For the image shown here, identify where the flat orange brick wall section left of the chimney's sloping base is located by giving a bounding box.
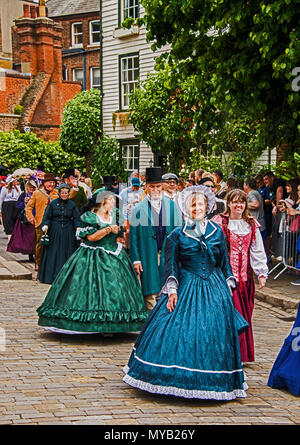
[0,74,30,114]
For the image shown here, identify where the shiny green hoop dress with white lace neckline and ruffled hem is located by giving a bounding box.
[37,212,148,333]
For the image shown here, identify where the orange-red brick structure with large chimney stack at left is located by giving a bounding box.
[0,2,81,140]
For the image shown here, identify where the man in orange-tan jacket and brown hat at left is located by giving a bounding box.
[25,173,58,270]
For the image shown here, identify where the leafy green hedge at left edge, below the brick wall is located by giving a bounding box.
[0,130,84,175]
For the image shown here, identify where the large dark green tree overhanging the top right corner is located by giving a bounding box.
[127,0,300,152]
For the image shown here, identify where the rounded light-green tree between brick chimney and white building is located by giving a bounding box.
[60,89,101,176]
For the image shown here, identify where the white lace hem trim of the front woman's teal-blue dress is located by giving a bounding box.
[123,366,248,400]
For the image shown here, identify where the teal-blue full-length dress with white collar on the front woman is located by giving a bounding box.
[123,221,248,400]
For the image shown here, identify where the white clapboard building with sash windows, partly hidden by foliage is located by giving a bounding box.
[100,0,169,171]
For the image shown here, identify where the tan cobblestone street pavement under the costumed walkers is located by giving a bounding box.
[0,280,300,425]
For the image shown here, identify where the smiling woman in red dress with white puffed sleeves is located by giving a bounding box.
[212,189,268,362]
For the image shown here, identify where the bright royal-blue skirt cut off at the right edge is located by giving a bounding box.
[268,305,300,396]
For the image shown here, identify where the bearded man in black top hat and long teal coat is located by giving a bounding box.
[129,167,182,312]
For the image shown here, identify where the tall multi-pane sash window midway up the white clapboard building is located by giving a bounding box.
[120,54,139,110]
